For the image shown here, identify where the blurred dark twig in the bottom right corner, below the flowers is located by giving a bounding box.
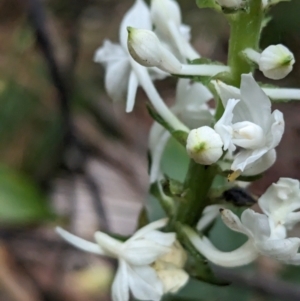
[214,267,300,301]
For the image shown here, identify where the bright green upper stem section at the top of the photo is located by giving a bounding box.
[228,0,264,87]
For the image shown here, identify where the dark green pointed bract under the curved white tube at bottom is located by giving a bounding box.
[175,222,229,286]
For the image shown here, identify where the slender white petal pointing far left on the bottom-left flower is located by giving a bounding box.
[56,227,109,255]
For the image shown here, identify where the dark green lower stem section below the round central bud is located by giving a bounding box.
[171,160,217,227]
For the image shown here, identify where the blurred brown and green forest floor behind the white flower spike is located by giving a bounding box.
[0,0,300,301]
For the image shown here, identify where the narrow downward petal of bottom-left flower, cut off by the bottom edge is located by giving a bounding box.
[111,259,129,301]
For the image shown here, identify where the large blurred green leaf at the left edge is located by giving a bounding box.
[0,166,54,226]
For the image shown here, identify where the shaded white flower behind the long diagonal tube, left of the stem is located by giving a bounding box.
[149,79,214,183]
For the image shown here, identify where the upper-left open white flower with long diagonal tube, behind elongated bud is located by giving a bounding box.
[94,0,188,131]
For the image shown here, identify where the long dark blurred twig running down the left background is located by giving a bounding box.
[29,0,107,228]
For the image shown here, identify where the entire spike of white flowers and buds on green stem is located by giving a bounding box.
[57,0,300,301]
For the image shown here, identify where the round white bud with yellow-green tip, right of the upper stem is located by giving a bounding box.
[258,44,295,79]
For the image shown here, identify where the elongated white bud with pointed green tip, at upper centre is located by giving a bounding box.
[127,27,181,73]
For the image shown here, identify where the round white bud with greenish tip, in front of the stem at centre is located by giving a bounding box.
[186,126,223,165]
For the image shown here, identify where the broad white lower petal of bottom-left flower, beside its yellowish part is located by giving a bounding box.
[127,265,163,301]
